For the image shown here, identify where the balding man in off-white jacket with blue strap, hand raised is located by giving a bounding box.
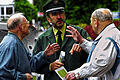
[66,8,120,80]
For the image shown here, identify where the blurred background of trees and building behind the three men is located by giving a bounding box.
[0,0,120,79]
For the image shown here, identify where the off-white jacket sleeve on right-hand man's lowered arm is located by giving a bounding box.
[73,40,117,78]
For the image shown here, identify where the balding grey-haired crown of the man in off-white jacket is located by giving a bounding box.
[92,8,113,21]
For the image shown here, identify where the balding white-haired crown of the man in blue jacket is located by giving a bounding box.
[7,13,25,30]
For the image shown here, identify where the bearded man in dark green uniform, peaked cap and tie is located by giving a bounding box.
[33,0,89,80]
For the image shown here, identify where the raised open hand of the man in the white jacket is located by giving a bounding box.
[66,26,84,43]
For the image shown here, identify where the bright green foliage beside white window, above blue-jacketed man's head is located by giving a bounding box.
[15,0,38,22]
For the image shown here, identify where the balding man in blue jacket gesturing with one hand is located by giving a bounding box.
[0,13,59,80]
